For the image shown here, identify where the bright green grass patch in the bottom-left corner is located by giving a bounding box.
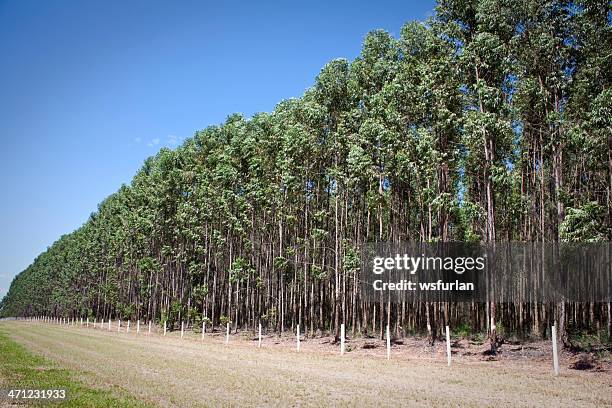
[0,329,150,407]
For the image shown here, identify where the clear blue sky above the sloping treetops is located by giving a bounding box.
[0,0,434,298]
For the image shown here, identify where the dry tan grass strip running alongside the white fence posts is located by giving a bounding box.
[0,321,612,407]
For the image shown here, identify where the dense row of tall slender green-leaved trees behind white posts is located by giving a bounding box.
[1,0,612,345]
